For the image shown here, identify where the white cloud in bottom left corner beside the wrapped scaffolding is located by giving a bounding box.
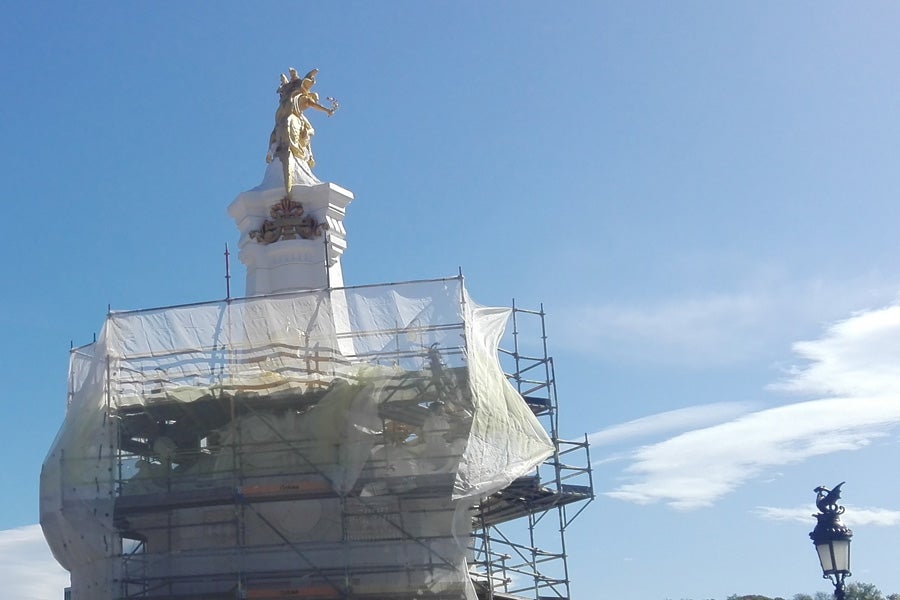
[0,525,69,600]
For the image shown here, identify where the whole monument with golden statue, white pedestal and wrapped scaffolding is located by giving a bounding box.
[41,69,593,600]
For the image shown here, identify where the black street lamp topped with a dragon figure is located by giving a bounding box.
[809,481,853,600]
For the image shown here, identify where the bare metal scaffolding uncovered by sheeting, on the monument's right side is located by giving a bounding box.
[472,301,594,600]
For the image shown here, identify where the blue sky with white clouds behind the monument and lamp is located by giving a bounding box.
[0,1,900,600]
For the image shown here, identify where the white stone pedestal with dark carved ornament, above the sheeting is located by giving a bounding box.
[228,182,353,296]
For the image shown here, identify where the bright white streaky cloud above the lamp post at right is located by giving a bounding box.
[594,306,900,508]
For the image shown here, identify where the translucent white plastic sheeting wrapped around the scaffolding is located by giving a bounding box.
[41,278,552,600]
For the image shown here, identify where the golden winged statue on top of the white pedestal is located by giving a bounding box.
[266,67,338,196]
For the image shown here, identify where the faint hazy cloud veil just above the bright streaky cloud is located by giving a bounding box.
[554,272,896,368]
